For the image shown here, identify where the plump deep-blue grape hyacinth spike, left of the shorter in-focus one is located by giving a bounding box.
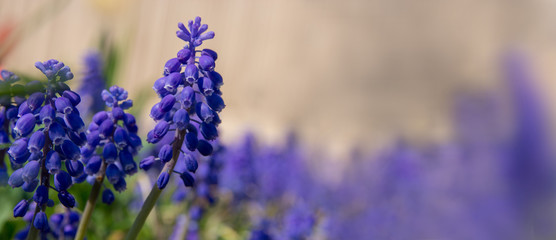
[8,59,86,237]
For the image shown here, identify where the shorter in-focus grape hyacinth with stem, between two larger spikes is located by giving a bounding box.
[76,86,142,239]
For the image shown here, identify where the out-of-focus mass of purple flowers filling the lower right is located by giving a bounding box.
[216,51,556,239]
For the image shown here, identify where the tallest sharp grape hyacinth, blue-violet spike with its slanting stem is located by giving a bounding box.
[126,17,225,239]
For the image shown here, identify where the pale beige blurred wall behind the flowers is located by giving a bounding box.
[0,0,556,157]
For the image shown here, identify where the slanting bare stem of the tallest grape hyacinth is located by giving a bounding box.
[125,130,185,240]
